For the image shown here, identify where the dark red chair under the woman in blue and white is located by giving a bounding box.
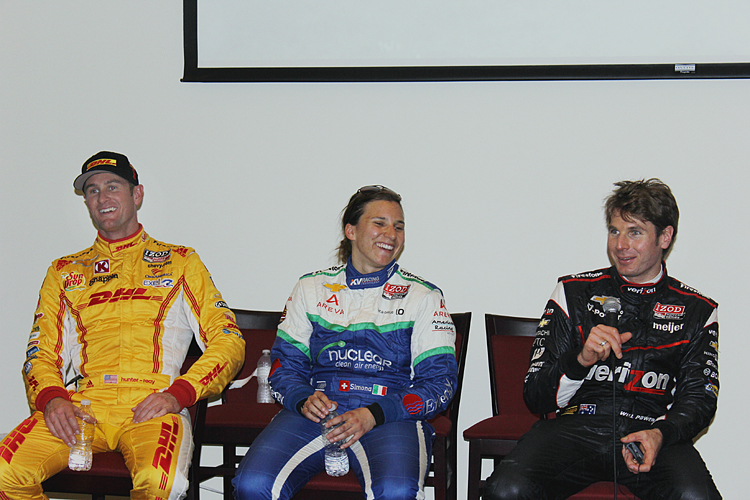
[295,312,471,500]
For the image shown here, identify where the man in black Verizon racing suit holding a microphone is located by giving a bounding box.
[485,179,721,500]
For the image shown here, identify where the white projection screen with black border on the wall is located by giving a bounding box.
[183,0,750,81]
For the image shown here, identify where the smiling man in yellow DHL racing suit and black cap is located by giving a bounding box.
[0,152,245,500]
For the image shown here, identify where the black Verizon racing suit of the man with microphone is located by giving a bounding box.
[488,265,720,498]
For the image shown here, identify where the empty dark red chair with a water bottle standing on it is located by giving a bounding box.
[196,309,282,500]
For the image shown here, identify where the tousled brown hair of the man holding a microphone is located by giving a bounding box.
[604,179,680,252]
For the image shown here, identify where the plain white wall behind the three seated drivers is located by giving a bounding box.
[0,0,750,498]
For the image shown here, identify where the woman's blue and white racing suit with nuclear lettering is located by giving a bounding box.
[234,260,457,499]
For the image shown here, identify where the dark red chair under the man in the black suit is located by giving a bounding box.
[463,314,635,500]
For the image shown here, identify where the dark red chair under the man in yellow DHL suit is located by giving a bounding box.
[42,340,207,500]
